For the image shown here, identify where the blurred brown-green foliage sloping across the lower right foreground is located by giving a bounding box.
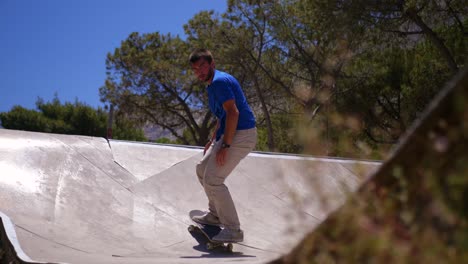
[273,68,468,264]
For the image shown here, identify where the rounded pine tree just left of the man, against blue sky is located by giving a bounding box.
[100,32,215,145]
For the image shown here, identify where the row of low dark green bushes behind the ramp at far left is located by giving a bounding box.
[0,96,146,141]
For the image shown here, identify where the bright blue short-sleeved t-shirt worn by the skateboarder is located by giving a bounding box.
[207,70,255,140]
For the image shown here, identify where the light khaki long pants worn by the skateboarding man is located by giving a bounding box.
[196,128,257,229]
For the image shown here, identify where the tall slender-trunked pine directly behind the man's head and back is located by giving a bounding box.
[185,4,288,151]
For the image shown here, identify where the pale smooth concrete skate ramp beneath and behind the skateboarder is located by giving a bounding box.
[0,129,380,263]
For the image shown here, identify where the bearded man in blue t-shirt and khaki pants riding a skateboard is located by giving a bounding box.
[189,49,257,242]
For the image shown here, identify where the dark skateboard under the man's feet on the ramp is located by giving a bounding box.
[188,210,234,252]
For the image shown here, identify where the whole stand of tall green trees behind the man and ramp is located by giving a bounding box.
[100,0,468,158]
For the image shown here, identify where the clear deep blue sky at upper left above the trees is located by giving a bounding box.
[0,0,227,112]
